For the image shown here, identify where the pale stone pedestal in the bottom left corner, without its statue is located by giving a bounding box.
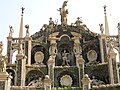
[0,72,12,90]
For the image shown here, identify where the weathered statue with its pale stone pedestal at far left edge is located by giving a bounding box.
[0,42,12,90]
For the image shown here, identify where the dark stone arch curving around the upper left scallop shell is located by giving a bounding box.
[31,45,49,65]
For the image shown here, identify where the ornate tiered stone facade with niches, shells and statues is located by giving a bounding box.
[0,1,120,90]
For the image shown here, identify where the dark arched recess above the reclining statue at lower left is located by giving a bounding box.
[25,70,45,86]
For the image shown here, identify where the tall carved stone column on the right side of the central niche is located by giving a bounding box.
[72,32,85,87]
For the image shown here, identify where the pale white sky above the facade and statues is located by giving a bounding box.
[0,0,120,54]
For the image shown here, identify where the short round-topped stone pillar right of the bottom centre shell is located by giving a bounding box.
[82,74,91,90]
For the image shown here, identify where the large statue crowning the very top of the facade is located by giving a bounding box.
[58,1,68,25]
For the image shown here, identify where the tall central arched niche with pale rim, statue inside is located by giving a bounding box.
[55,34,76,66]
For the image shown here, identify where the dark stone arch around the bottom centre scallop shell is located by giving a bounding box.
[56,70,78,87]
